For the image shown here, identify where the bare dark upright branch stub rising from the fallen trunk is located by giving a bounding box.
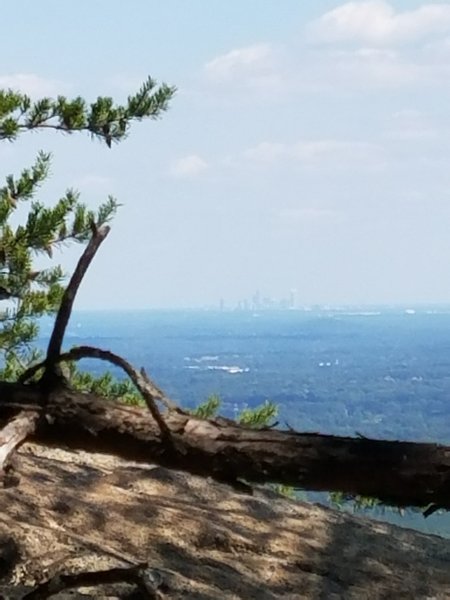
[42,224,109,380]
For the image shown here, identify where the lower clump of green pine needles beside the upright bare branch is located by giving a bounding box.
[0,153,117,368]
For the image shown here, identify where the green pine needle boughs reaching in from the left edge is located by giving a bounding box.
[0,78,175,381]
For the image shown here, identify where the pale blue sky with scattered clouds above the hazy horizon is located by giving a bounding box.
[0,0,450,308]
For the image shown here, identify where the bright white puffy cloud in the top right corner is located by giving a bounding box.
[309,0,450,45]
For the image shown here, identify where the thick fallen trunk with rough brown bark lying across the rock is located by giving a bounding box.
[0,382,450,508]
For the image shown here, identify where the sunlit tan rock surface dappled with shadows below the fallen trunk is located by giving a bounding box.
[0,444,450,600]
